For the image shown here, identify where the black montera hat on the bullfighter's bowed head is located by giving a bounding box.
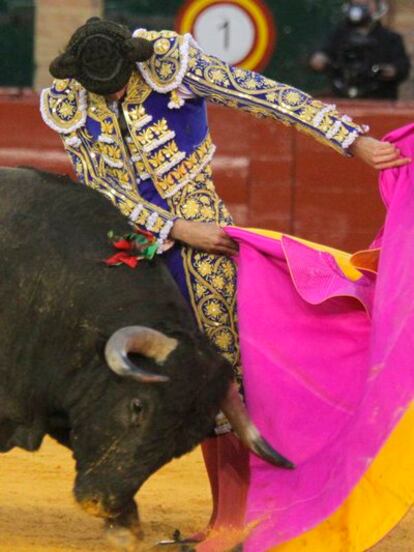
[49,17,154,95]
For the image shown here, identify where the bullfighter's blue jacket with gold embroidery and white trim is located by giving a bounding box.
[41,29,365,241]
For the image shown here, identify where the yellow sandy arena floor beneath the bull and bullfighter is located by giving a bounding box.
[0,440,414,552]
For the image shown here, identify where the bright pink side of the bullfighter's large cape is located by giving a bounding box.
[227,125,414,552]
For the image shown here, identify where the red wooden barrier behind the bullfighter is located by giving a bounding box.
[0,92,414,250]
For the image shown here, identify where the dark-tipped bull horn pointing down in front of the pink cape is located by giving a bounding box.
[221,384,295,470]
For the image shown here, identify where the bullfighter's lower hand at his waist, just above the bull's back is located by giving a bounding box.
[170,219,238,257]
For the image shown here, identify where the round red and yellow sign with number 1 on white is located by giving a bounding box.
[176,0,276,71]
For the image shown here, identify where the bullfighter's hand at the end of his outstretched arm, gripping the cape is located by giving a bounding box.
[350,136,412,170]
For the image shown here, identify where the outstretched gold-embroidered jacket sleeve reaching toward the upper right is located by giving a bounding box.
[182,45,368,154]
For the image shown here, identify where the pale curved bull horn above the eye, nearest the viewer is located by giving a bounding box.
[105,326,178,383]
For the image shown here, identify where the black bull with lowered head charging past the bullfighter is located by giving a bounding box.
[0,169,288,544]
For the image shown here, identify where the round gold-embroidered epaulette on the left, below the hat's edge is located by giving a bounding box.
[40,79,88,134]
